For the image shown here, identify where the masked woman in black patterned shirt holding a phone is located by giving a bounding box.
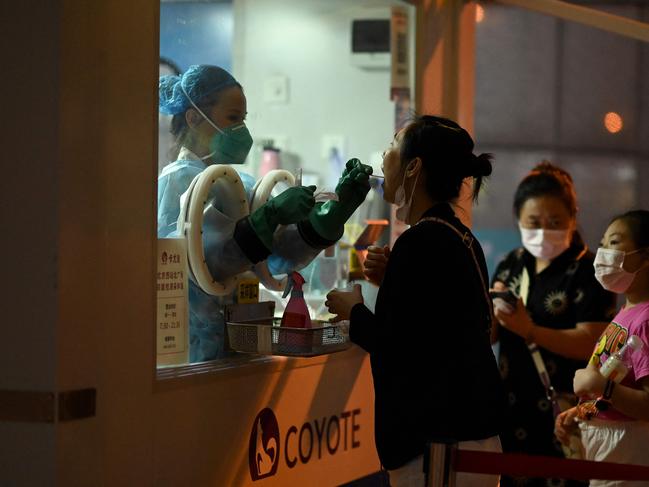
[493,162,615,487]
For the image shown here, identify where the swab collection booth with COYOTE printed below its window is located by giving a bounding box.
[0,0,647,487]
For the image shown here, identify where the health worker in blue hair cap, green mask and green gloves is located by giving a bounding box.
[158,65,372,362]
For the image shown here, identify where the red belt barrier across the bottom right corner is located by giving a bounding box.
[453,450,649,480]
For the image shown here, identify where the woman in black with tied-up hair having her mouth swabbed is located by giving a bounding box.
[325,116,505,487]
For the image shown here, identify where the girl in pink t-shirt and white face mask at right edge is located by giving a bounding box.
[556,210,649,487]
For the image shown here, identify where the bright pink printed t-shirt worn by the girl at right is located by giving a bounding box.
[589,302,649,421]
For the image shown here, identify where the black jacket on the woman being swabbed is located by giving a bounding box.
[350,204,506,470]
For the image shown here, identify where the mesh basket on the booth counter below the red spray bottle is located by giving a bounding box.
[227,318,351,357]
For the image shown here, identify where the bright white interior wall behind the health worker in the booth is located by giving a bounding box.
[232,0,408,188]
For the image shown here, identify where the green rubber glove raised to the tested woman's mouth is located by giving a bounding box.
[309,159,372,241]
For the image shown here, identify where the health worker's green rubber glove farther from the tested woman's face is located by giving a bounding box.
[248,186,316,250]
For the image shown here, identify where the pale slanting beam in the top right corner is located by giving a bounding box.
[496,0,649,42]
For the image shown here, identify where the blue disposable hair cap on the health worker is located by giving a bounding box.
[158,64,240,115]
